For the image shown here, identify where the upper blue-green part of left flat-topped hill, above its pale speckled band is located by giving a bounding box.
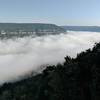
[0,23,65,32]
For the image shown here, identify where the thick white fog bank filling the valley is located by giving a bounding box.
[0,31,100,83]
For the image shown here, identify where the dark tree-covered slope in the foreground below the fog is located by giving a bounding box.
[0,43,100,100]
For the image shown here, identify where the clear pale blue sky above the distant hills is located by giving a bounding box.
[0,0,100,26]
